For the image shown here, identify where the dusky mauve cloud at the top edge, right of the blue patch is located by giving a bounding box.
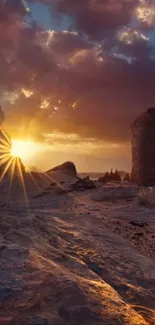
[51,0,139,38]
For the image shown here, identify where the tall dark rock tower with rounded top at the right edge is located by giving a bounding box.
[131,108,155,186]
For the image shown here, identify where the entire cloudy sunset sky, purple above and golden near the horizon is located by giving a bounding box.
[0,0,155,172]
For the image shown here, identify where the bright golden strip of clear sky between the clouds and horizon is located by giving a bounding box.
[12,133,130,172]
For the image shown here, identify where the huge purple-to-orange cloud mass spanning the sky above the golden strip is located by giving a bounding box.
[0,0,155,143]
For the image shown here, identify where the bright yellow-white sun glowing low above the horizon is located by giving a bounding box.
[11,140,37,159]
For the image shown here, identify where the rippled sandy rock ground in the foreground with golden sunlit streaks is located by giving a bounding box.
[0,176,155,325]
